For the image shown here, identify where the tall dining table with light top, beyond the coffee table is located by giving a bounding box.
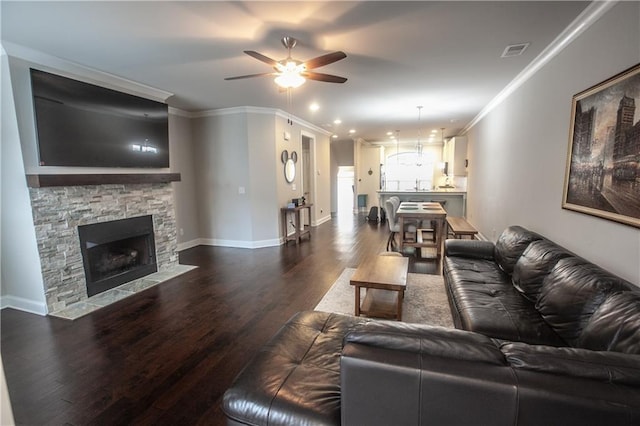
[396,202,447,258]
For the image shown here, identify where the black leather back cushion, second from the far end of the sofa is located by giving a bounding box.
[512,239,571,303]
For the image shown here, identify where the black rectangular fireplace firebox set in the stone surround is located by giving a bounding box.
[78,215,158,297]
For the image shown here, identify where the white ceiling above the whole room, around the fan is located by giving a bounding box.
[0,0,588,142]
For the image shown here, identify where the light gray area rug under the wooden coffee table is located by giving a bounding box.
[315,268,453,327]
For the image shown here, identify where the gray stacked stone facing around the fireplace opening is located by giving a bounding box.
[30,183,178,312]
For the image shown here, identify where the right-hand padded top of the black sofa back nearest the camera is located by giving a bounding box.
[500,342,640,386]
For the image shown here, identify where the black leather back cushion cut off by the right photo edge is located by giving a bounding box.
[578,291,640,354]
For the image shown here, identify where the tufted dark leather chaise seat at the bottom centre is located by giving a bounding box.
[222,311,370,425]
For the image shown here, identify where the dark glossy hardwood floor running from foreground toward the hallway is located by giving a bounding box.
[1,215,440,425]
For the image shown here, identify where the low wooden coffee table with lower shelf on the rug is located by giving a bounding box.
[350,256,409,321]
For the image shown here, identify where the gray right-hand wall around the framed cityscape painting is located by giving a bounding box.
[467,2,640,284]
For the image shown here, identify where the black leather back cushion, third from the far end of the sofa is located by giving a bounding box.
[536,257,633,346]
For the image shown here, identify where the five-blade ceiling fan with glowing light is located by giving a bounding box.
[225,37,347,89]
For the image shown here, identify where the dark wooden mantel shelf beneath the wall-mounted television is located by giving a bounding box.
[27,173,181,188]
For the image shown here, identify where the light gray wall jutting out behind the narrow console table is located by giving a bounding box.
[192,107,329,248]
